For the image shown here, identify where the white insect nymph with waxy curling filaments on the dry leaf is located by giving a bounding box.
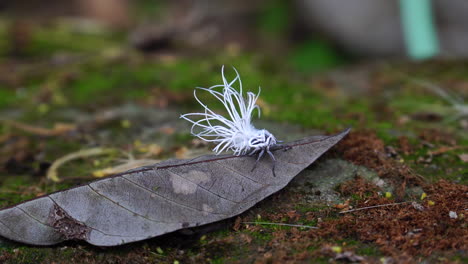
[181,66,277,161]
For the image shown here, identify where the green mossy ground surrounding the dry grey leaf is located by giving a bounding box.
[0,17,468,263]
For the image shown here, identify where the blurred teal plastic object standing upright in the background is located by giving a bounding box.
[400,0,439,60]
